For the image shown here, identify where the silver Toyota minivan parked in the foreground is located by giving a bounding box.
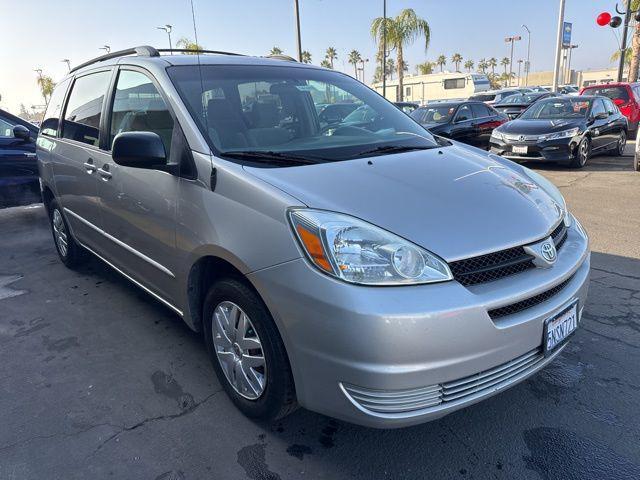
[37,47,590,428]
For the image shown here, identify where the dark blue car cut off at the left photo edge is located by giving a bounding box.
[0,110,39,207]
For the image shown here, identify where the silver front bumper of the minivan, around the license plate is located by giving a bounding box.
[250,224,590,428]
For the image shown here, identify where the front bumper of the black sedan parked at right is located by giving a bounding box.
[490,136,581,162]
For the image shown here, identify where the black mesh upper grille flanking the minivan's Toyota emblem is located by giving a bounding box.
[449,222,567,286]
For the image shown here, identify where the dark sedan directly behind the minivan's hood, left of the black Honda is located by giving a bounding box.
[411,101,508,149]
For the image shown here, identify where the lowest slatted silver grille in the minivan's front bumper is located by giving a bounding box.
[342,347,544,415]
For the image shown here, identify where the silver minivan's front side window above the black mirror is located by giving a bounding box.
[109,70,173,152]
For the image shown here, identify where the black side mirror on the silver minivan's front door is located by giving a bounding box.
[111,132,167,170]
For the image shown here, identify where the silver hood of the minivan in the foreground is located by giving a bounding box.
[245,144,562,261]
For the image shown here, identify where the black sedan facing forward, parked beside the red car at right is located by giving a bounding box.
[491,96,628,168]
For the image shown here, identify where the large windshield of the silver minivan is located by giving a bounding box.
[167,65,438,161]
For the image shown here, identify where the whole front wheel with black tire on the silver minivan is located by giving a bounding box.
[203,278,297,421]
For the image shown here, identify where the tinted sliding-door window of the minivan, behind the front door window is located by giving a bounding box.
[62,71,111,147]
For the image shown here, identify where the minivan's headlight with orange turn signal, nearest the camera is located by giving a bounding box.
[289,209,453,285]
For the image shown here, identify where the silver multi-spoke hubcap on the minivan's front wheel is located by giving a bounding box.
[211,301,267,400]
